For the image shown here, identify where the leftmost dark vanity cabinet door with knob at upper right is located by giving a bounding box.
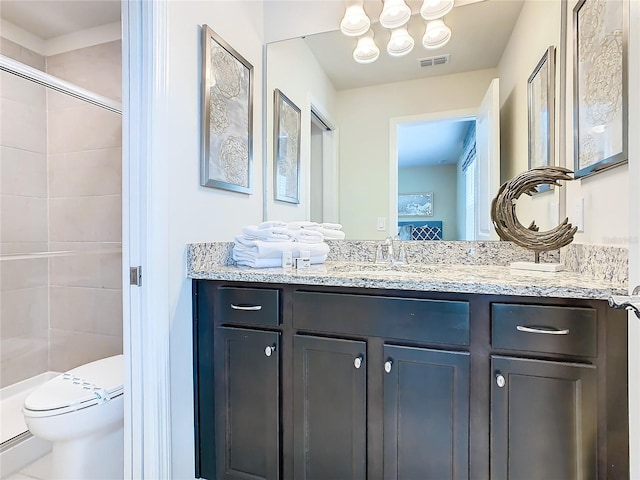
[214,327,280,480]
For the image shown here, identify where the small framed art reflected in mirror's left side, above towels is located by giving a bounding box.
[273,88,300,203]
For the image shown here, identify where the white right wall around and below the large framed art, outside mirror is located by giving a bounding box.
[565,0,636,247]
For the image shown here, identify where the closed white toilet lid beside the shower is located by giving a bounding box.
[24,355,124,411]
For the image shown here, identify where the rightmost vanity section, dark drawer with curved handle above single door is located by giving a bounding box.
[490,303,598,480]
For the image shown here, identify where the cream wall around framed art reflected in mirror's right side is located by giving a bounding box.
[498,0,564,230]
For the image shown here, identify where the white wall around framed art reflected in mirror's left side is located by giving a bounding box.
[265,38,336,221]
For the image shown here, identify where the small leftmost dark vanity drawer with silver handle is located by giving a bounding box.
[218,287,280,326]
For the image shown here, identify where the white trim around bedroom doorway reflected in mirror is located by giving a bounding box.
[387,108,478,235]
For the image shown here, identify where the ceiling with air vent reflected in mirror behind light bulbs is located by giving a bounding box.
[304,0,524,90]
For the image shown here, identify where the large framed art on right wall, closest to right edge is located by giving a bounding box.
[573,0,628,178]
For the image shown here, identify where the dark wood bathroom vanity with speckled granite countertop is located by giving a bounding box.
[189,256,628,480]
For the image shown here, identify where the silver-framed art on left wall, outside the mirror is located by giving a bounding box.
[200,25,253,193]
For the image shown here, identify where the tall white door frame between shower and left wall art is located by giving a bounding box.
[121,0,172,479]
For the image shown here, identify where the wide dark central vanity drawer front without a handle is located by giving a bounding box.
[293,291,469,345]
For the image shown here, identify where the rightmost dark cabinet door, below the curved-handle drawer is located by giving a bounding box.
[491,356,598,480]
